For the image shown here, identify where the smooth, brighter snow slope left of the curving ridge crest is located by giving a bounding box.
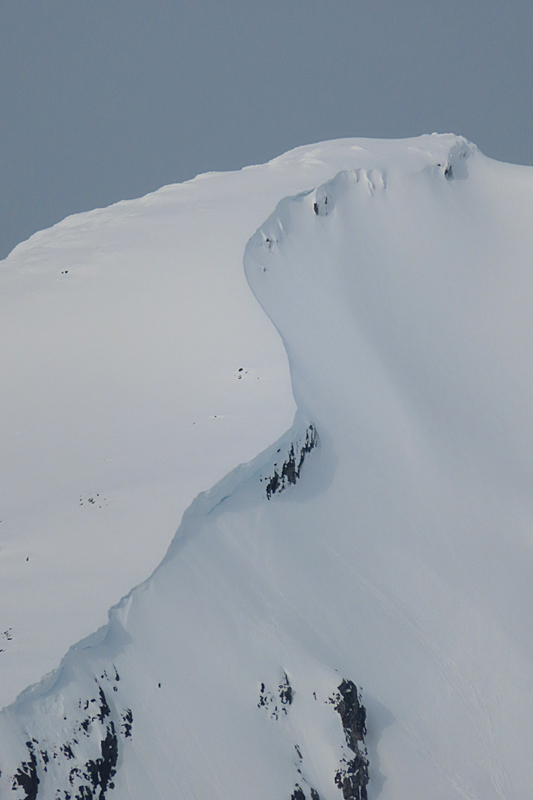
[0,142,376,707]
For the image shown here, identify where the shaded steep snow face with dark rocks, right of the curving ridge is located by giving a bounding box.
[0,136,533,800]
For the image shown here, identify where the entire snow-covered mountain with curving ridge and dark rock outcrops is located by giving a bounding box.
[0,135,533,800]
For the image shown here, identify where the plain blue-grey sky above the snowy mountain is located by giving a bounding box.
[0,0,533,257]
